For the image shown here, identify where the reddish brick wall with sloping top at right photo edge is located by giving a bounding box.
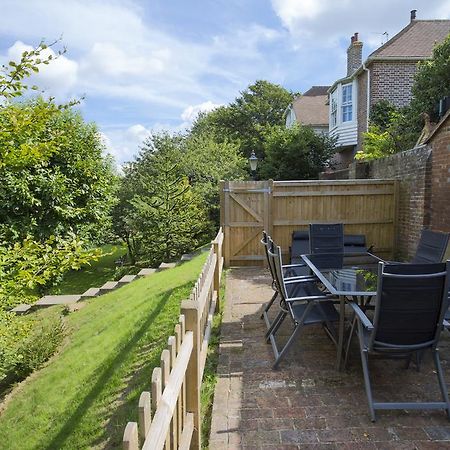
[429,116,450,237]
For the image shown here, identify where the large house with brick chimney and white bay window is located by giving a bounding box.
[328,10,450,168]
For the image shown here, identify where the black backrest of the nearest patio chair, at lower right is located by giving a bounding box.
[370,262,450,351]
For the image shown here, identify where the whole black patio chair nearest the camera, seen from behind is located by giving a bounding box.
[350,261,450,422]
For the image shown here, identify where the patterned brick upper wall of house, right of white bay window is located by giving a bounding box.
[370,61,417,107]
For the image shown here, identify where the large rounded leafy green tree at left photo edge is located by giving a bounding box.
[0,98,115,241]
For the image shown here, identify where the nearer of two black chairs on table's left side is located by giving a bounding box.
[266,242,339,369]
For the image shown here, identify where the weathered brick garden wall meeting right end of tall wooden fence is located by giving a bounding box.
[349,146,431,260]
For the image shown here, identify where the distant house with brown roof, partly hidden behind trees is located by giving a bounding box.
[285,86,330,134]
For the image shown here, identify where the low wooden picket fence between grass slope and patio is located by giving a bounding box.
[123,229,224,450]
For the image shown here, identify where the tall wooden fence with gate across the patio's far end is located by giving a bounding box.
[220,180,398,266]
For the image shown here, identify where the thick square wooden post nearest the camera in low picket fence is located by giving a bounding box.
[181,300,201,450]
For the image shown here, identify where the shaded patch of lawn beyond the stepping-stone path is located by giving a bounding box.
[49,245,127,294]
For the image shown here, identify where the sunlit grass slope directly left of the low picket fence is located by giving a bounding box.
[0,254,206,450]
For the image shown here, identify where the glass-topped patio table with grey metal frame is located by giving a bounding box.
[302,253,383,370]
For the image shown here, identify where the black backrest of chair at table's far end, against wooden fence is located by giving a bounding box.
[309,223,344,253]
